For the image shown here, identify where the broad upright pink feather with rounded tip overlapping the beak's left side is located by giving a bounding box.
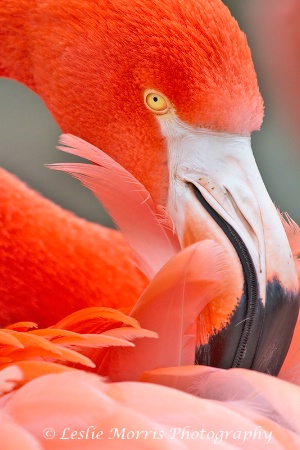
[93,241,237,381]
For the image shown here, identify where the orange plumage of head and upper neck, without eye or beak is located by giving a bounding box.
[0,0,263,204]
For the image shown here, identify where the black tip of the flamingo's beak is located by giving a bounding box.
[195,278,299,376]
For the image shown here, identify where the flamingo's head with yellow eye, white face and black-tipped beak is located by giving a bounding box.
[6,0,299,373]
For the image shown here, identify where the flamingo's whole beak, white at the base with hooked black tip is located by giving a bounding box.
[160,118,299,375]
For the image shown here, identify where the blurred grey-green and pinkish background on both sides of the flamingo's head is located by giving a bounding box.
[0,0,300,226]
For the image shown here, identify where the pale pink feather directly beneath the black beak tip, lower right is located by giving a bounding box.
[141,366,300,449]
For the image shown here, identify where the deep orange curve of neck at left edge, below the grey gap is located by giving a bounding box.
[0,170,148,326]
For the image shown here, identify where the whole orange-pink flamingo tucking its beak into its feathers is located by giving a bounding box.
[0,0,299,449]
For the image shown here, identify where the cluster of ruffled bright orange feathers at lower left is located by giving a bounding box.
[0,307,157,384]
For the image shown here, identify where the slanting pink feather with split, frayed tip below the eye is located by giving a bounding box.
[48,134,179,279]
